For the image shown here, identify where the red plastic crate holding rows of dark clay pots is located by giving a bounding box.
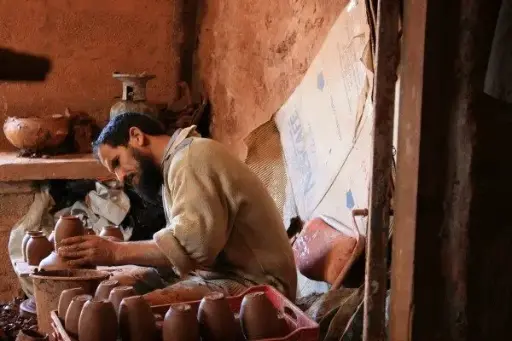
[152,285,319,341]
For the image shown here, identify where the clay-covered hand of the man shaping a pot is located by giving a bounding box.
[57,236,119,265]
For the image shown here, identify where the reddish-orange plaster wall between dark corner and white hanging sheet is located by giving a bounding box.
[198,0,348,158]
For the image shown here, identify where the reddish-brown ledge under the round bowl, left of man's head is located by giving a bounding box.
[0,152,112,182]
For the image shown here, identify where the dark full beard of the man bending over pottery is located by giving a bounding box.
[127,148,163,204]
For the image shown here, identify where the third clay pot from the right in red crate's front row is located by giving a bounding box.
[163,304,199,341]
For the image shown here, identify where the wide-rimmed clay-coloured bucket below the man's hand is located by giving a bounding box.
[30,269,110,333]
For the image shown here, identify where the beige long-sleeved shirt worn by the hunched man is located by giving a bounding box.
[154,127,297,299]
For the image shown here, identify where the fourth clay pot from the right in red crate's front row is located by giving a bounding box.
[119,296,157,341]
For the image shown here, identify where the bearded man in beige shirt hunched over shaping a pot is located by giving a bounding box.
[58,113,297,304]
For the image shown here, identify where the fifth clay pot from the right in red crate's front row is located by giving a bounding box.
[78,299,117,341]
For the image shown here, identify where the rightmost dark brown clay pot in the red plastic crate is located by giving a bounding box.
[240,292,286,340]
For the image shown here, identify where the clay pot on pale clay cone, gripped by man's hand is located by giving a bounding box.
[39,215,85,270]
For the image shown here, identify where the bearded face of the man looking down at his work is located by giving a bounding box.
[98,145,163,203]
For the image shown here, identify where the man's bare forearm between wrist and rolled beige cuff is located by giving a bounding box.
[115,240,172,267]
